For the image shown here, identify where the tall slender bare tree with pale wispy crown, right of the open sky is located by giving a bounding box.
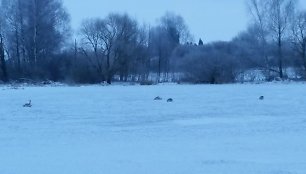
[248,0,296,78]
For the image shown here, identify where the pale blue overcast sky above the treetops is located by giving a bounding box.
[63,0,306,42]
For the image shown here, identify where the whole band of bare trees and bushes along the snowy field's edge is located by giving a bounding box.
[0,0,306,84]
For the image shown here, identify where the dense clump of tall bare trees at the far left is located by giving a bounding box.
[2,0,70,78]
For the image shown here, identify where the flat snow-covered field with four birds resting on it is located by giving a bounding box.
[0,84,306,174]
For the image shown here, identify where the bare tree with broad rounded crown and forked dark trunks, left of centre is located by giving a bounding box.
[81,14,139,84]
